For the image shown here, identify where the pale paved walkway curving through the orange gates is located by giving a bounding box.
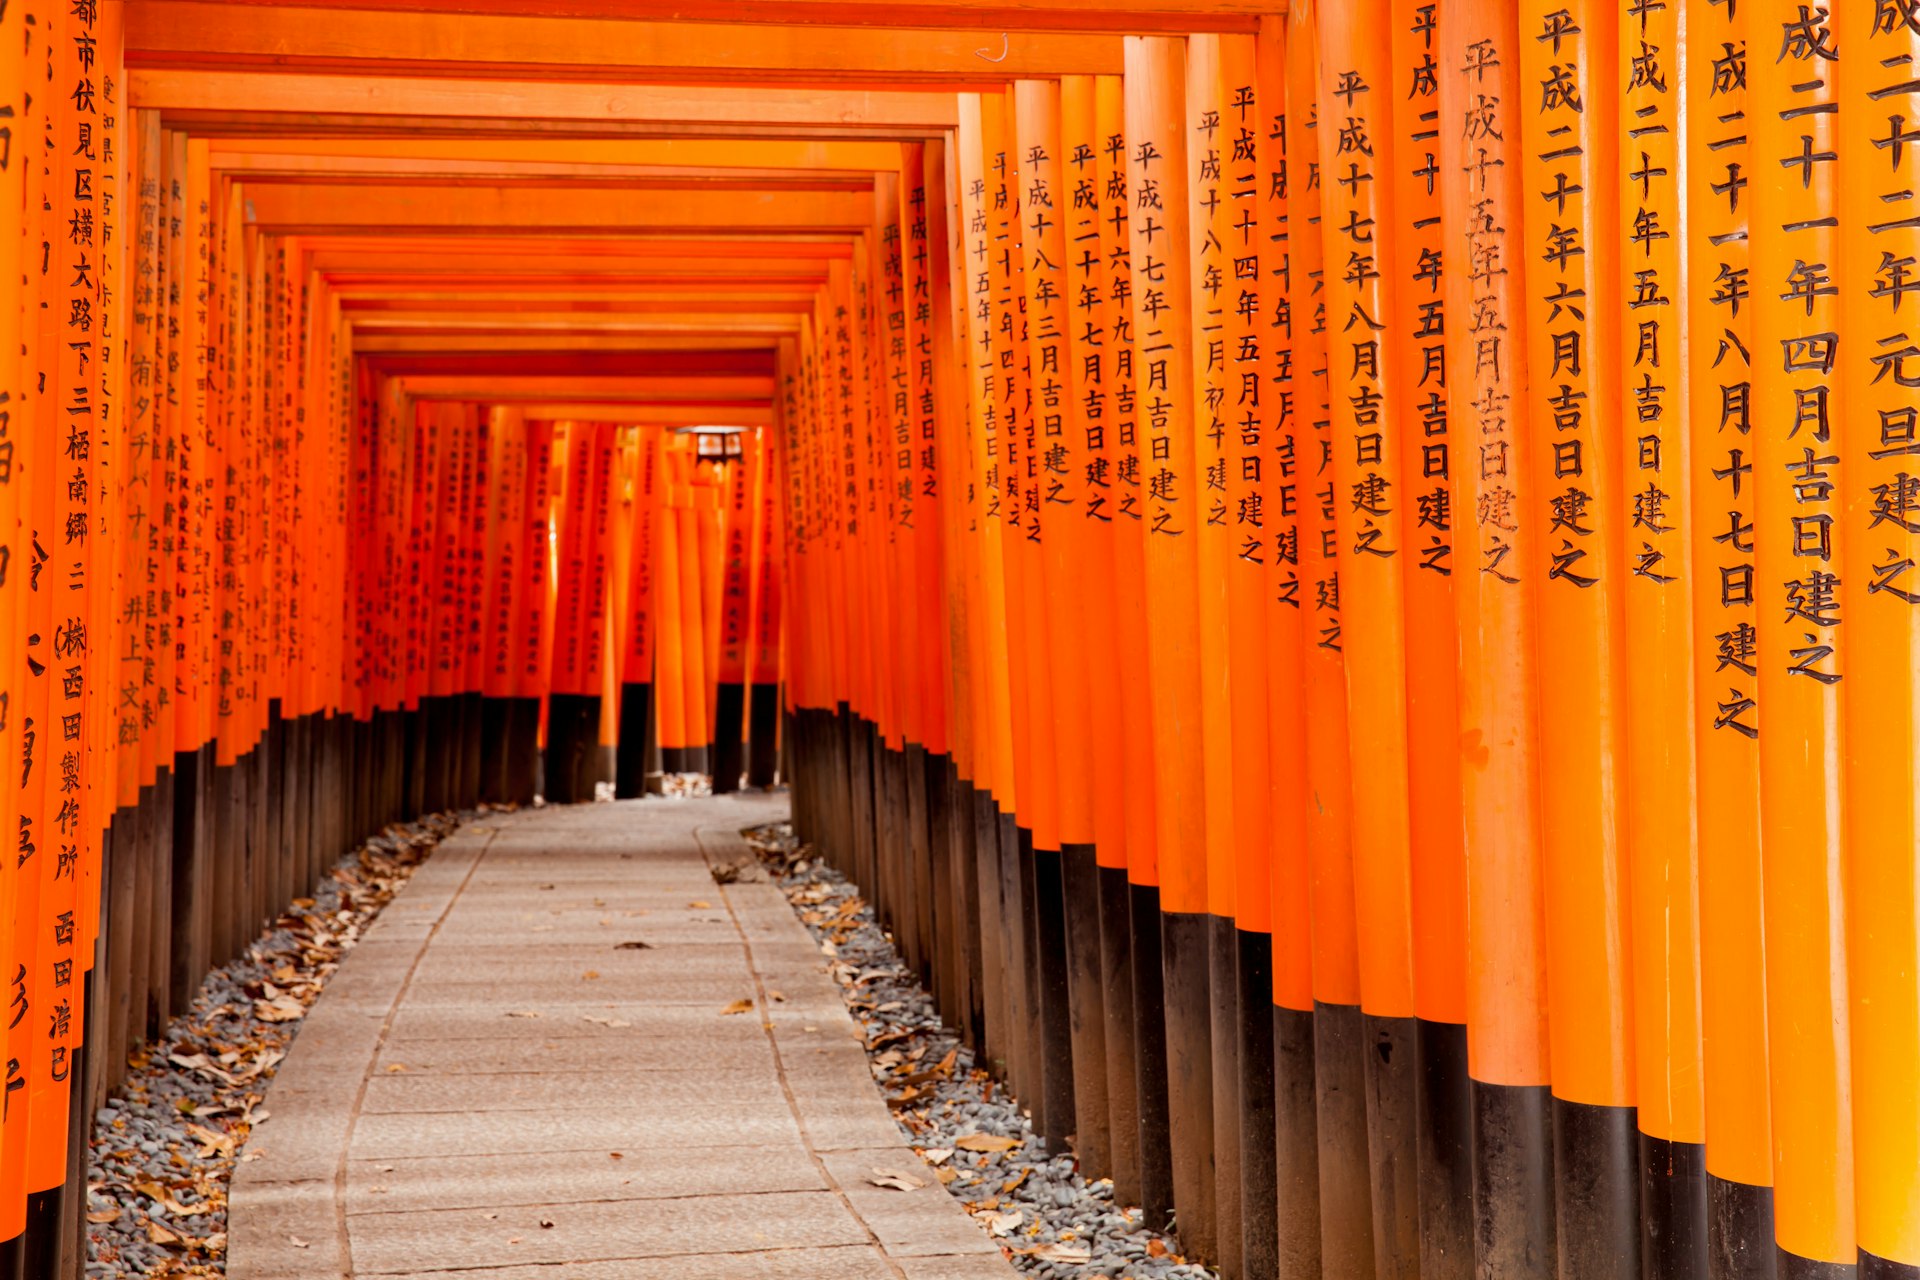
[227,796,1014,1280]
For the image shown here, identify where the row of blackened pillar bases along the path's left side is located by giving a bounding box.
[0,695,568,1280]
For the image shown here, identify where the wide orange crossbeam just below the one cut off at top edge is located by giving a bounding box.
[127,0,1123,84]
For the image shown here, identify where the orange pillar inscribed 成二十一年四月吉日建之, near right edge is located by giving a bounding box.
[1758,0,1858,1276]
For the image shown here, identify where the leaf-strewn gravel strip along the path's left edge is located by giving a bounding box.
[86,814,478,1280]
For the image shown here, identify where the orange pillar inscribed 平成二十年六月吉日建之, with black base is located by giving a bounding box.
[1521,0,1635,1274]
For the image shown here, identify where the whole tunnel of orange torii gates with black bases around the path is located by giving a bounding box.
[0,0,1920,1280]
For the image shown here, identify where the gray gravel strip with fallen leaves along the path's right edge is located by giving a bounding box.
[745,823,1213,1280]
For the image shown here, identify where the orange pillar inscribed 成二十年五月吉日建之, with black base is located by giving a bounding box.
[1599,0,1711,1280]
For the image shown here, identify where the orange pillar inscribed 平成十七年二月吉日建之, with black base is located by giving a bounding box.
[1125,36,1219,1257]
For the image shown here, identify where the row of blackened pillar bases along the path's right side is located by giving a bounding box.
[783,706,1781,1280]
